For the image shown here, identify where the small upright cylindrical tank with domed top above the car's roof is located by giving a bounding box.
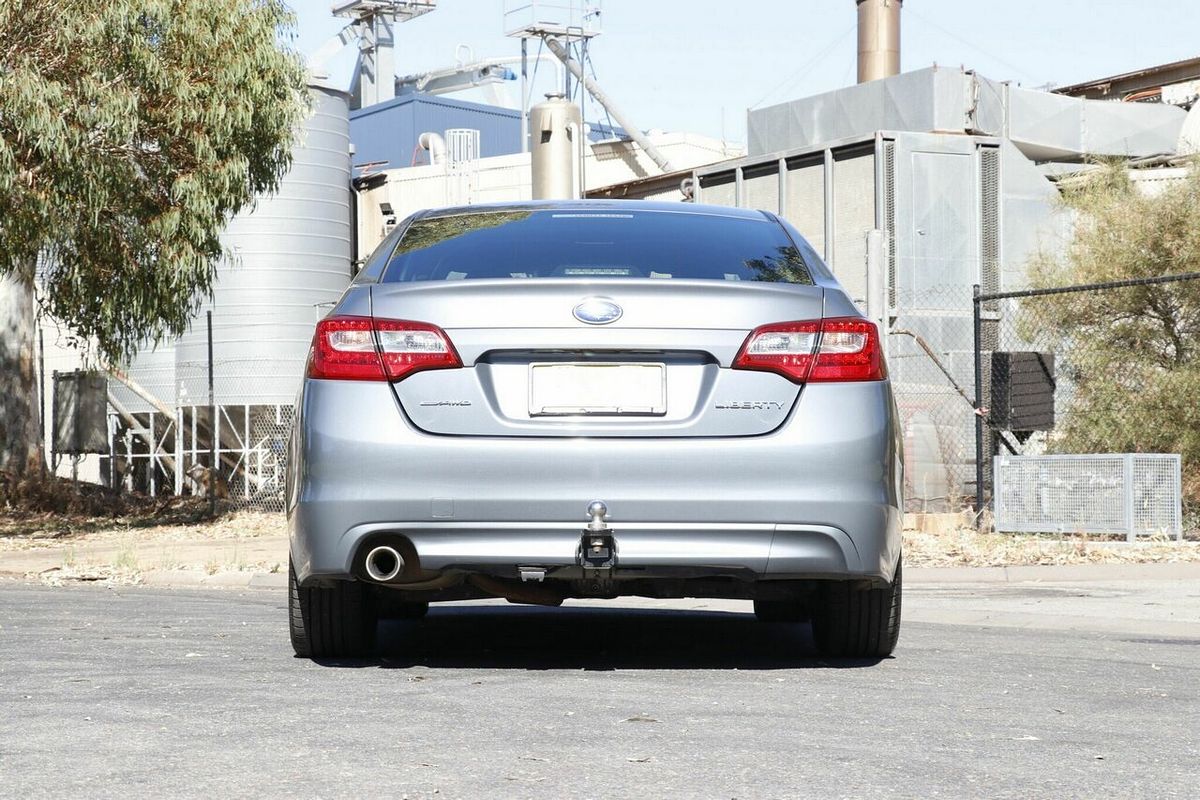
[529,95,583,200]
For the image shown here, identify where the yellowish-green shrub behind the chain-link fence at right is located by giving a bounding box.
[1022,166,1200,500]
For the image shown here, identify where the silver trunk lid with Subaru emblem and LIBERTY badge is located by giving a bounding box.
[371,278,823,437]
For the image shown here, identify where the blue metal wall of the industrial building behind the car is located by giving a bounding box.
[350,94,521,169]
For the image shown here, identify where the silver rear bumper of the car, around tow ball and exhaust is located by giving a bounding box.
[288,380,901,582]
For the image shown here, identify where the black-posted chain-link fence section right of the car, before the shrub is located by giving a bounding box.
[971,273,1200,529]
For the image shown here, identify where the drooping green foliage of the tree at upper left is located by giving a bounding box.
[0,0,307,361]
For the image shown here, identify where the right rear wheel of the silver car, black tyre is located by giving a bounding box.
[812,556,902,658]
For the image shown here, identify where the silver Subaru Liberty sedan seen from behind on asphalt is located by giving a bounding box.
[288,201,902,657]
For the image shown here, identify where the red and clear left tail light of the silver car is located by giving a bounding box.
[308,317,462,380]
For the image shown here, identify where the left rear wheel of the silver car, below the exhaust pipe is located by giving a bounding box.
[288,559,379,658]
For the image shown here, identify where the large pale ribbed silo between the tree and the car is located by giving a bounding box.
[175,84,352,405]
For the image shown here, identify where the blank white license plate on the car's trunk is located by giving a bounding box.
[529,363,667,416]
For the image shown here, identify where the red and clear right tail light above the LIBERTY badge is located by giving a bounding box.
[733,317,887,384]
